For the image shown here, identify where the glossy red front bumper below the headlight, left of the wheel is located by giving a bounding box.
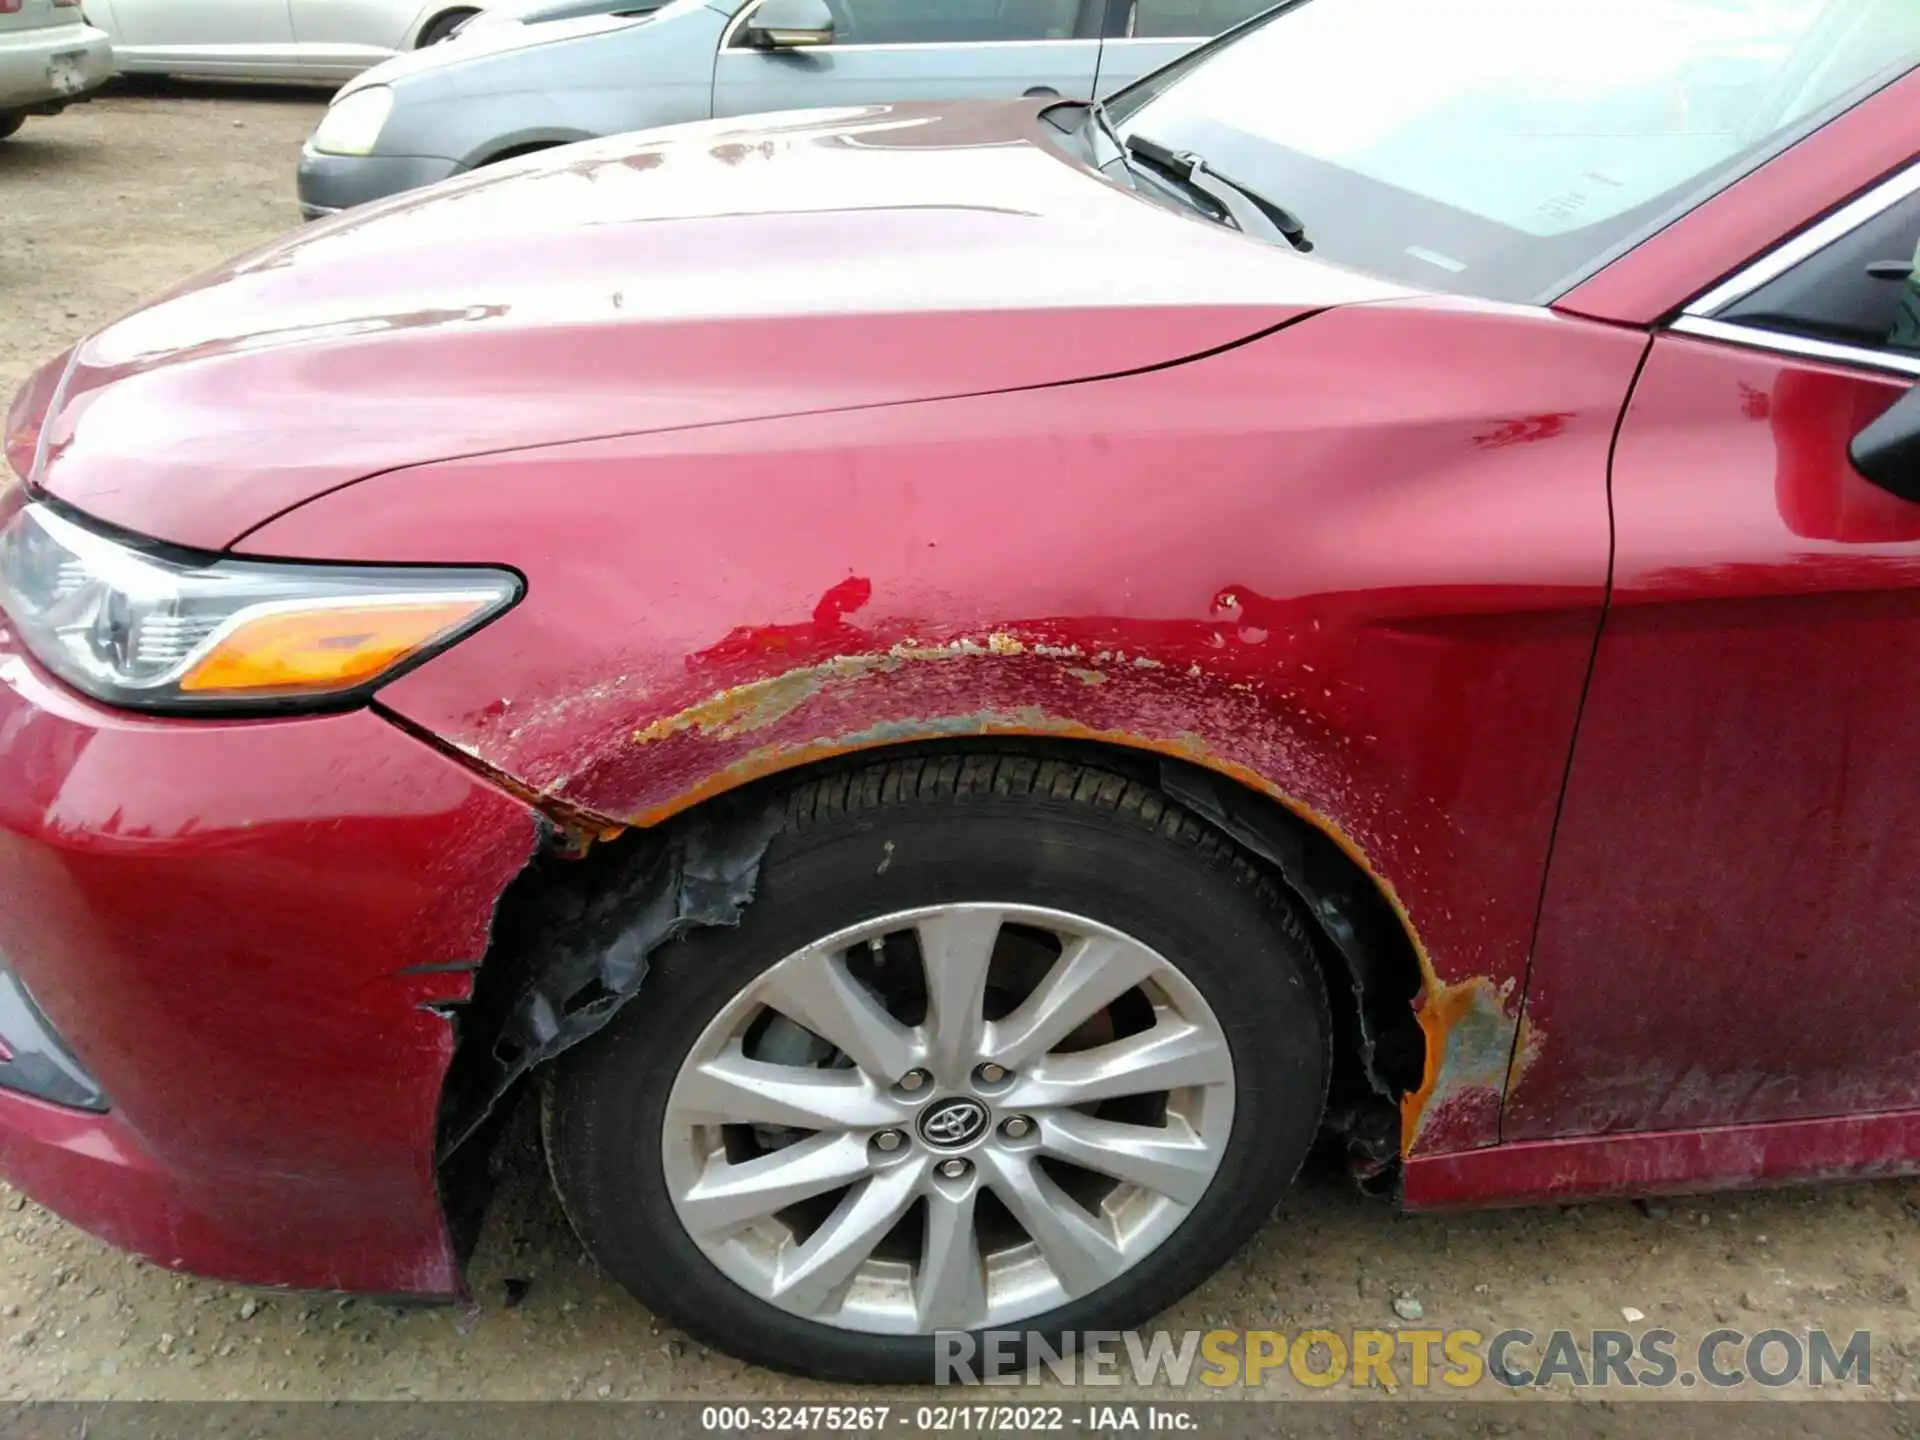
[0,622,538,1296]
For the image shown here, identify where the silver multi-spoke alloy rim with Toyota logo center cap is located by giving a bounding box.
[660,895,1236,1336]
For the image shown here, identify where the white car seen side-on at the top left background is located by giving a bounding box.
[86,0,579,81]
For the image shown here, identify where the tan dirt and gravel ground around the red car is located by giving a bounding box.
[0,88,1920,1400]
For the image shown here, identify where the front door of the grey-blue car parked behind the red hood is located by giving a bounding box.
[714,0,1102,115]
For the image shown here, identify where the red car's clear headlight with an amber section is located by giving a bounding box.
[0,503,520,710]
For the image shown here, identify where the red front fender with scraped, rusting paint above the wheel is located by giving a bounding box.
[248,303,1640,1148]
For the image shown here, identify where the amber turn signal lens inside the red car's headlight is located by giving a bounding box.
[180,595,499,695]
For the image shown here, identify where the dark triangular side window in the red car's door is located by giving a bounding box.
[1715,194,1920,357]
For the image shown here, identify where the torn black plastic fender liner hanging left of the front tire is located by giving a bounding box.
[440,797,785,1160]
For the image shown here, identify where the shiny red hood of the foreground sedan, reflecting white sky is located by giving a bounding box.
[36,102,1396,549]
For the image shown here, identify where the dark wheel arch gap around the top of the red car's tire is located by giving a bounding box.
[440,733,1428,1252]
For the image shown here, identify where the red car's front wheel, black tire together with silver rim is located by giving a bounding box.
[543,756,1331,1382]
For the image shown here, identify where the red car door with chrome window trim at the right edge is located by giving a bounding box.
[1501,167,1920,1139]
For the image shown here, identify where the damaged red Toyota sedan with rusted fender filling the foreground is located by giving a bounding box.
[0,0,1920,1379]
